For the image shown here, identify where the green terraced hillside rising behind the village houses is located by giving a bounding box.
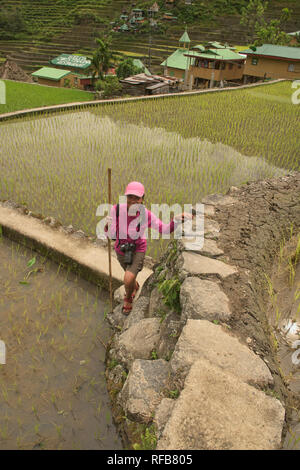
[0,0,300,71]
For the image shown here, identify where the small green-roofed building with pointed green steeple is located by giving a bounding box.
[160,30,193,81]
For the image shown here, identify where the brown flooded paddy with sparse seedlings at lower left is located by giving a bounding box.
[0,237,122,450]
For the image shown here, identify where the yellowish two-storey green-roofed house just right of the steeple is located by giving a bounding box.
[185,42,245,88]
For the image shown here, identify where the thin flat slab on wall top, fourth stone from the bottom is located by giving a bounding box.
[176,252,238,279]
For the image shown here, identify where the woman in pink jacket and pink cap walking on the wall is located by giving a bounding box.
[108,181,191,315]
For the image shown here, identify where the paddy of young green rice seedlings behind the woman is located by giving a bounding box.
[0,83,299,260]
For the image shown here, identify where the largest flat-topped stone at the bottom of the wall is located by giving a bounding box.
[157,359,285,450]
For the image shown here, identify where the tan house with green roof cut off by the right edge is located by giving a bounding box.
[243,44,300,83]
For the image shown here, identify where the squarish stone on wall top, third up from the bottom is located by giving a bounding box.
[180,277,231,321]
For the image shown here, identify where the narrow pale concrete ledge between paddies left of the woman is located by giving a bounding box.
[0,203,152,289]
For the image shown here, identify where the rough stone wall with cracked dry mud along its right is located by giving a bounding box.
[107,173,300,450]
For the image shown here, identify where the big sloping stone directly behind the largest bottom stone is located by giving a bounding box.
[170,320,273,387]
